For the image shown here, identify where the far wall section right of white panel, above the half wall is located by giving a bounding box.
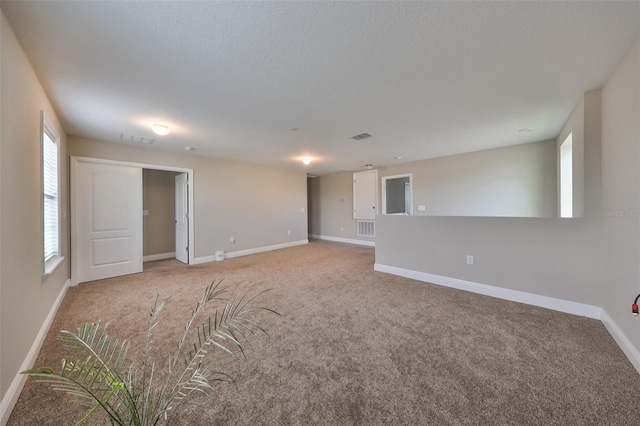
[380,140,557,217]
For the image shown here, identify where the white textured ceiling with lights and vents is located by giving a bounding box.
[1,1,640,174]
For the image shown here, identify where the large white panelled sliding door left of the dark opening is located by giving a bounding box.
[72,160,142,283]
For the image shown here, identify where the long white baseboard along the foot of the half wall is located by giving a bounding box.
[373,263,602,319]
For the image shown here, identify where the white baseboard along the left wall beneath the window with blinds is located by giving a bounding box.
[0,280,71,425]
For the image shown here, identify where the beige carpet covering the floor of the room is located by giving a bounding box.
[9,241,640,426]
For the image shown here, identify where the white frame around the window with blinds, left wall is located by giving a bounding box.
[40,111,64,280]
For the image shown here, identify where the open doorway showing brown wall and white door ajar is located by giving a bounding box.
[142,169,189,264]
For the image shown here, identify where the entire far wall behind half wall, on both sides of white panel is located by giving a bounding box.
[309,140,557,242]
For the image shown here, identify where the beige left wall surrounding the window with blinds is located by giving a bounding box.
[0,10,69,408]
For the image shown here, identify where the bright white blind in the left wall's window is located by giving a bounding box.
[42,120,60,263]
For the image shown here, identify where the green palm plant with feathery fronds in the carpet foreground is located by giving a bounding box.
[22,280,278,426]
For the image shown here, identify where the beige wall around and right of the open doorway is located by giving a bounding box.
[69,136,307,261]
